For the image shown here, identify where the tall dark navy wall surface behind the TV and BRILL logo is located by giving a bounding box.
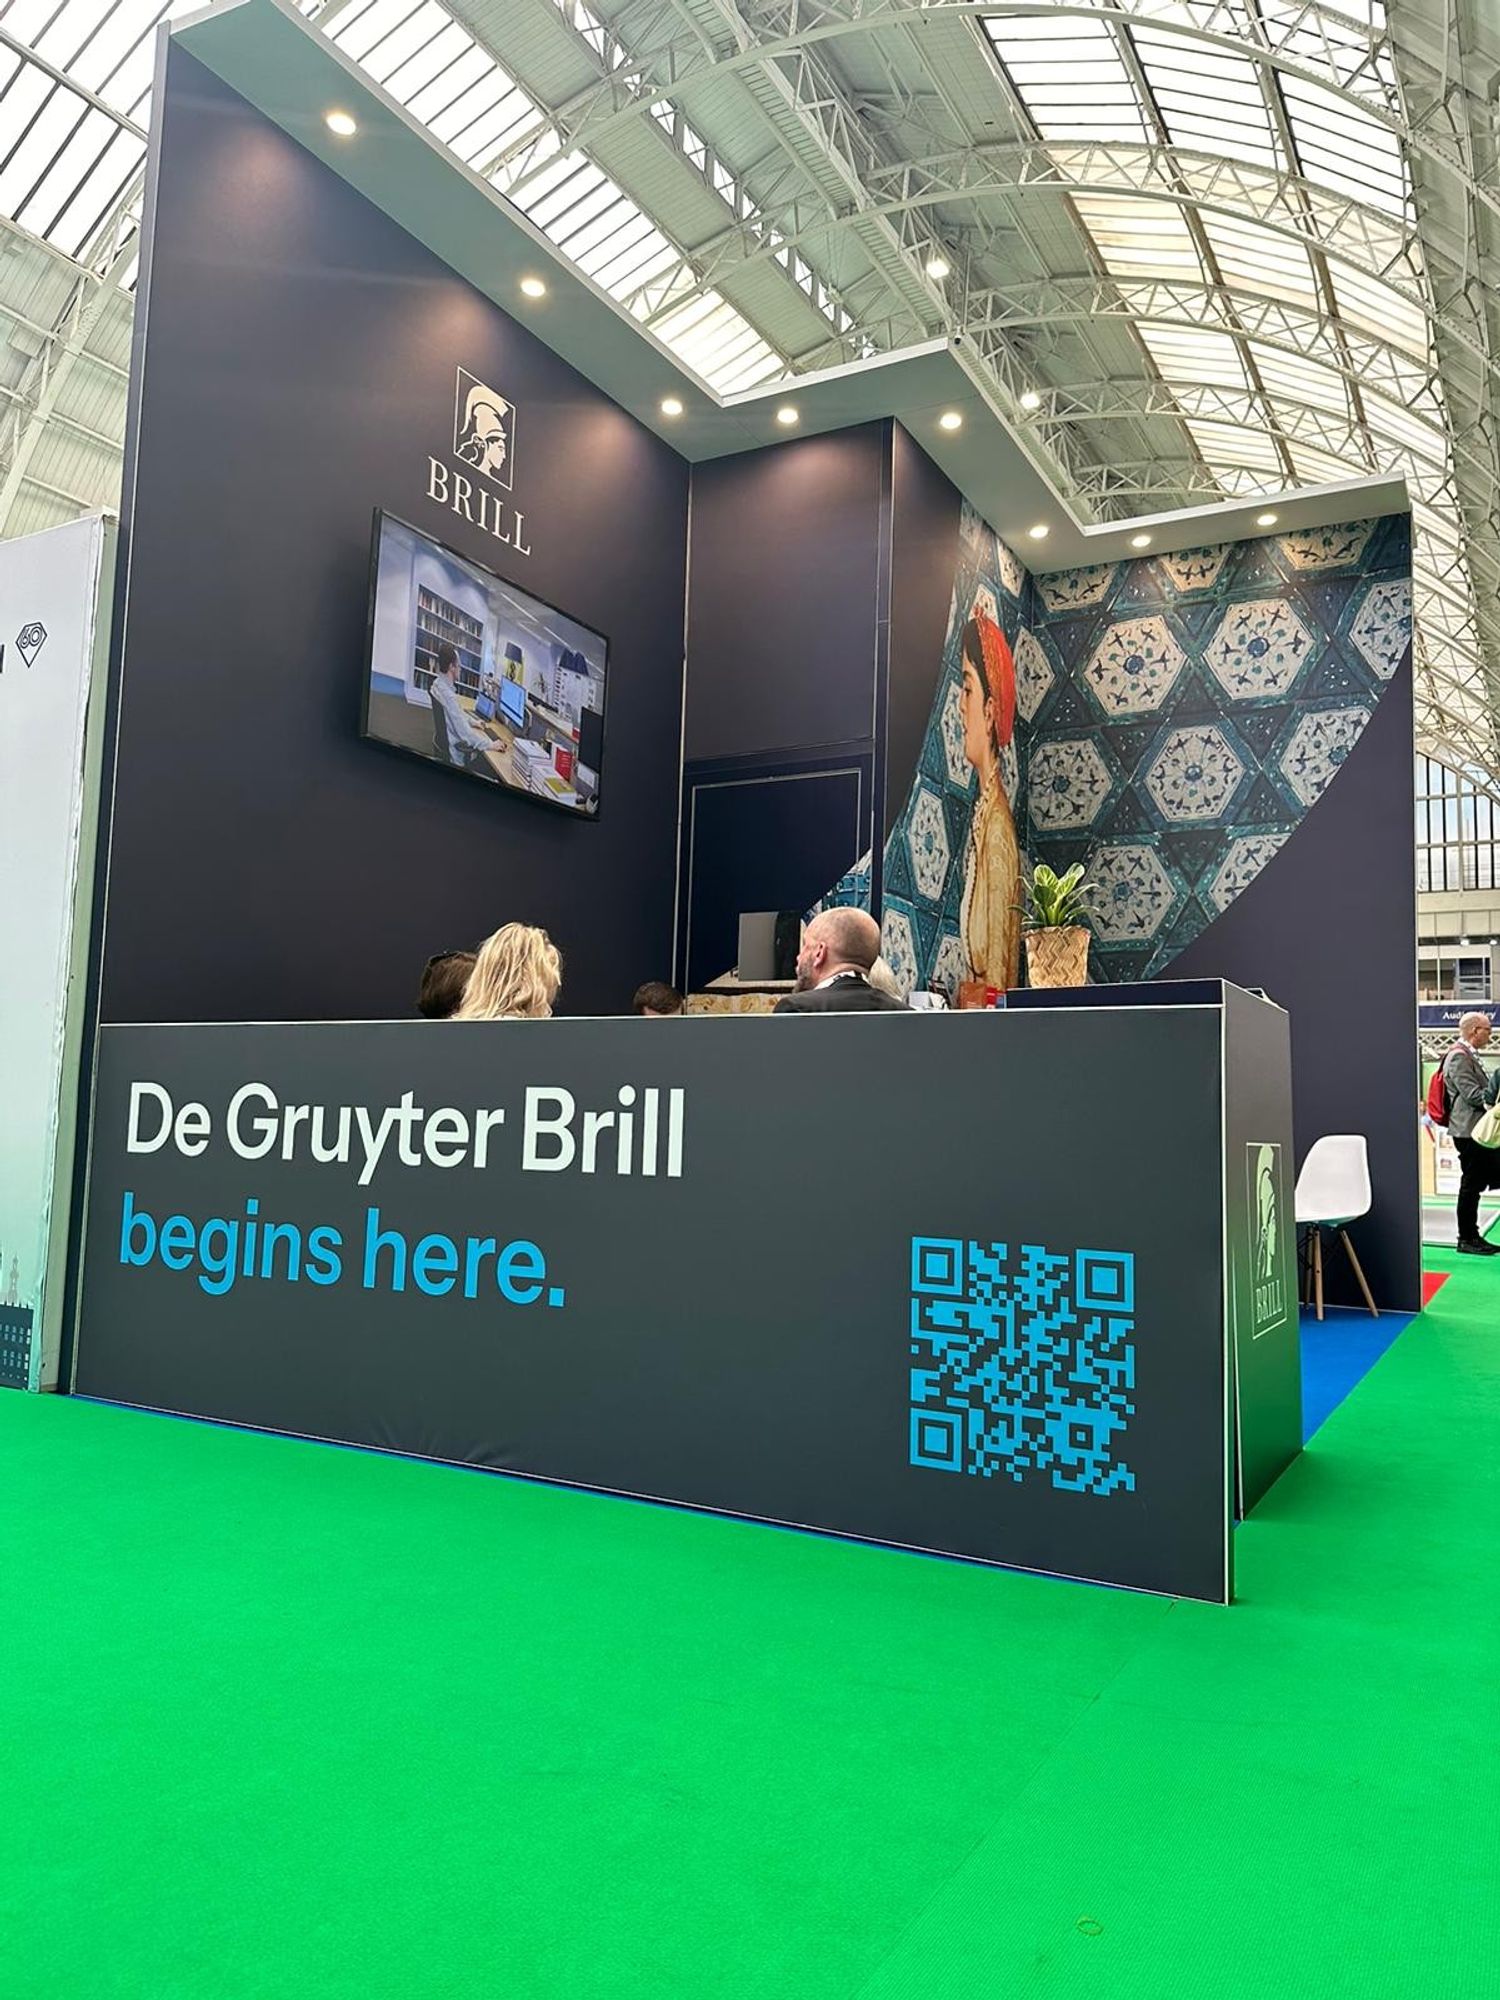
[102,48,688,1022]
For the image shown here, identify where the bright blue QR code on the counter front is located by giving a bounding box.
[912,1236,1136,1496]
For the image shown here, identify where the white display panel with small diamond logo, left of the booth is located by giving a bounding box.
[0,516,114,1388]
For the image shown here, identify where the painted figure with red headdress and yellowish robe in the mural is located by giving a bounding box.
[958,614,1020,992]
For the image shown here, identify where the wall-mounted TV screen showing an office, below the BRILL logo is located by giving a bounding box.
[362,514,610,816]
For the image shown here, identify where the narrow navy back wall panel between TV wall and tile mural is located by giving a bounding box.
[678,424,892,986]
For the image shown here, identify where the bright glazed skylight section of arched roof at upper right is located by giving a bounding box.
[984,0,1486,768]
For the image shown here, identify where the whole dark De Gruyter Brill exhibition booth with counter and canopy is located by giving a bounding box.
[2,0,1420,1600]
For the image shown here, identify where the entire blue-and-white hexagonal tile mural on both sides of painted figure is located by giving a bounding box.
[820,508,1412,992]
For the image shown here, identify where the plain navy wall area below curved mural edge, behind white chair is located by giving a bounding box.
[1170,662,1422,1312]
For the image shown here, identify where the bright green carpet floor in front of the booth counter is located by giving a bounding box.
[0,1258,1500,2000]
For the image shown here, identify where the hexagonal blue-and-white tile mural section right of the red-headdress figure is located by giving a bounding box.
[1028,516,1412,980]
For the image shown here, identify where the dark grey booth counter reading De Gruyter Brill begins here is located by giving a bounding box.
[74,984,1300,1600]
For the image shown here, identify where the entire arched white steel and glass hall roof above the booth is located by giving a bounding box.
[0,0,1500,784]
